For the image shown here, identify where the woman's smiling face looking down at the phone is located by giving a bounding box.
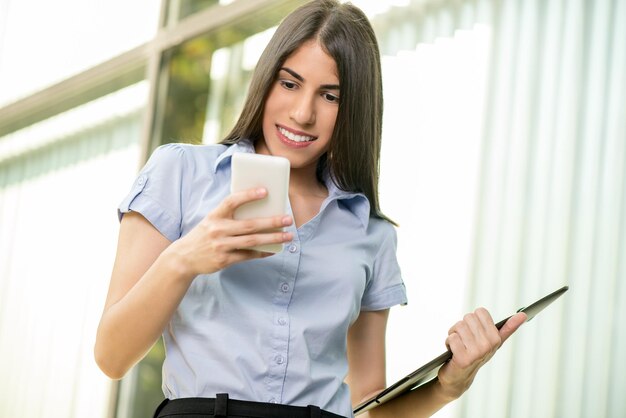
[256,41,339,172]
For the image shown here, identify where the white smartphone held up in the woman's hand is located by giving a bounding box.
[230,152,289,253]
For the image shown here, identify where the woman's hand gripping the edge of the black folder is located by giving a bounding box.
[438,308,526,399]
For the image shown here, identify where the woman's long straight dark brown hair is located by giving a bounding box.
[221,0,393,223]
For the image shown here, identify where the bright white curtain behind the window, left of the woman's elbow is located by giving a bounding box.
[0,83,147,418]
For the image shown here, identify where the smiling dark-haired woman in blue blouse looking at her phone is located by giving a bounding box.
[95,0,524,418]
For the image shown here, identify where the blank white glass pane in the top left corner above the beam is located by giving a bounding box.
[0,0,159,107]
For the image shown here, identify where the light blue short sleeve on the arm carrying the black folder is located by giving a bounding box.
[361,224,407,311]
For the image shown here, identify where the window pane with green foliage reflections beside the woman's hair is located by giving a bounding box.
[151,2,297,148]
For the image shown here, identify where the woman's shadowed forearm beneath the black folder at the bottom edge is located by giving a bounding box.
[359,379,456,418]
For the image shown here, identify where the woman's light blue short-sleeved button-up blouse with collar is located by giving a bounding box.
[119,141,406,416]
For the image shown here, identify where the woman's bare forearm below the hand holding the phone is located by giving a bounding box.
[94,250,193,379]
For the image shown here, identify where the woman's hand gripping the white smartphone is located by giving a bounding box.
[166,188,293,277]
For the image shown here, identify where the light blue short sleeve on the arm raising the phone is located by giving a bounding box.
[118,144,186,241]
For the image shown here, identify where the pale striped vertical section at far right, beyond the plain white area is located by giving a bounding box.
[463,0,626,417]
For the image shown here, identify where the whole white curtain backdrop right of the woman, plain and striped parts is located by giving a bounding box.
[374,0,626,418]
